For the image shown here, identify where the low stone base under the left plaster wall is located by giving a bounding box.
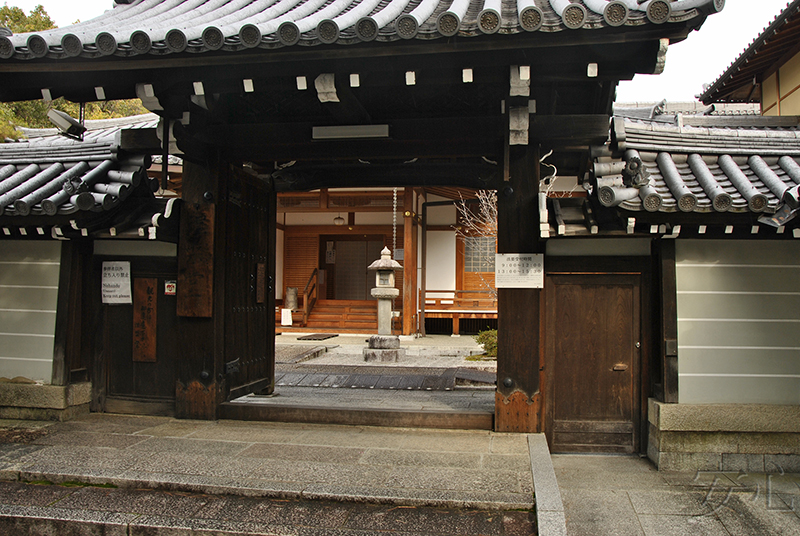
[0,382,92,421]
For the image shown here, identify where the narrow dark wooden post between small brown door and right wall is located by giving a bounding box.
[658,240,678,404]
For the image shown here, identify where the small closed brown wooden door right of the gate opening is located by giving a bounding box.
[545,274,641,453]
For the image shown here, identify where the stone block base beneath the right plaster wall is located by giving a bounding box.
[647,399,800,473]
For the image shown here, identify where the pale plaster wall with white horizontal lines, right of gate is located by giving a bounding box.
[676,240,800,405]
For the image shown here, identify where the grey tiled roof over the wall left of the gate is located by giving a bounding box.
[0,114,177,239]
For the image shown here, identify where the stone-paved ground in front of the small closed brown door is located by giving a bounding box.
[552,455,800,536]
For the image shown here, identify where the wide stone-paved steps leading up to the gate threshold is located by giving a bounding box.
[0,414,534,536]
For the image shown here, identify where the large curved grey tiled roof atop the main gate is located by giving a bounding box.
[0,0,725,59]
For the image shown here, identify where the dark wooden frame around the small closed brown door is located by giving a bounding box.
[539,256,657,453]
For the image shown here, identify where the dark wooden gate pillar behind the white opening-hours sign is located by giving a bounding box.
[495,141,543,433]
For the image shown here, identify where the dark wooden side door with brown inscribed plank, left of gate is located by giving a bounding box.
[95,258,177,415]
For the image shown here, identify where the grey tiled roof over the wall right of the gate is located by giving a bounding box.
[594,118,800,218]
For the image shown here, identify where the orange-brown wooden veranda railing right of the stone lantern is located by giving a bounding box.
[419,290,497,335]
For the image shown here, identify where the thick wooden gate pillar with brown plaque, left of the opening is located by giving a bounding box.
[175,157,225,420]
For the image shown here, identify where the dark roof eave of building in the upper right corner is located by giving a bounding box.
[699,0,800,104]
